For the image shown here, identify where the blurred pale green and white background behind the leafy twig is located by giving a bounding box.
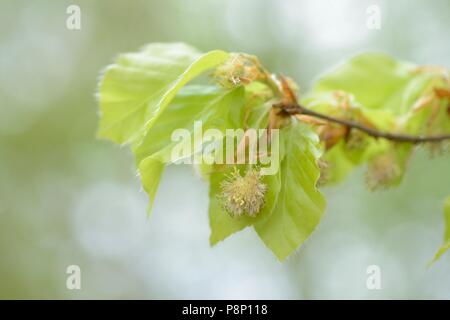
[0,0,450,299]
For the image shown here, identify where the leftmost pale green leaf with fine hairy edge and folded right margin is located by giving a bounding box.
[98,43,228,143]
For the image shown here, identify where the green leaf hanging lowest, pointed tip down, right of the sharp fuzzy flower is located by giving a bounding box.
[254,122,326,261]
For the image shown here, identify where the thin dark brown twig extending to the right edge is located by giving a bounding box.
[274,103,450,144]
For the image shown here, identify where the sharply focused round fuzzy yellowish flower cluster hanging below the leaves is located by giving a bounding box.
[219,169,267,217]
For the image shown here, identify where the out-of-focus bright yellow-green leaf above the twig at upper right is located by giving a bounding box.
[313,53,448,123]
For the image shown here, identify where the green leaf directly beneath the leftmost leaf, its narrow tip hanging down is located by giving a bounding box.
[137,86,244,212]
